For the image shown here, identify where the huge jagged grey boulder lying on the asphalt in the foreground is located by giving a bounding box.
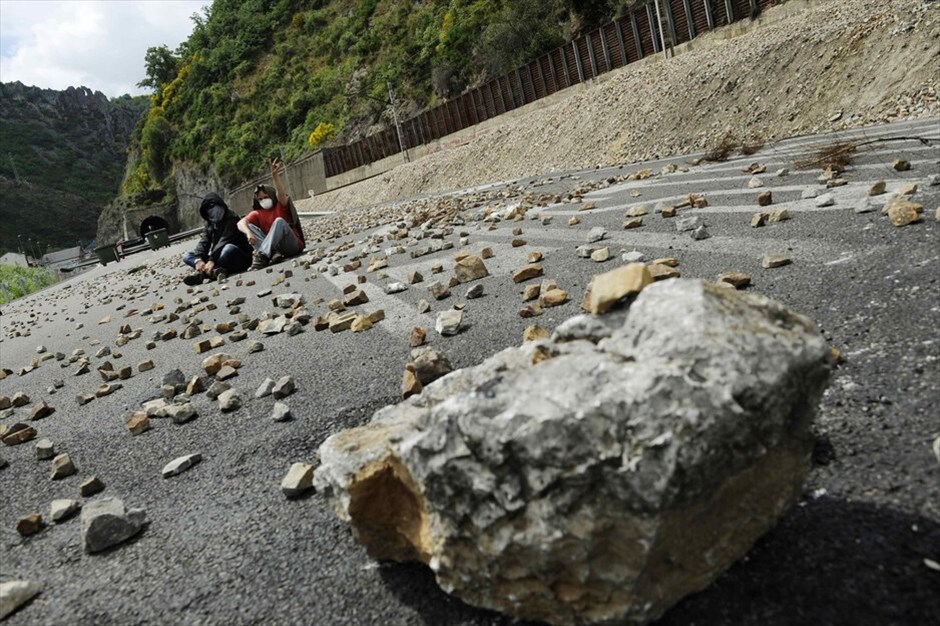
[315,280,829,624]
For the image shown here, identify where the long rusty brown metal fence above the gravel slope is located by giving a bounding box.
[323,0,784,177]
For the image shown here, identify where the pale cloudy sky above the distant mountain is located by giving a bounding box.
[0,0,212,97]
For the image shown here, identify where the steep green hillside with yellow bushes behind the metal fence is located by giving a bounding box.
[125,0,629,193]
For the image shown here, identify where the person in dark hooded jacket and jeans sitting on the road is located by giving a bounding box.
[183,193,252,285]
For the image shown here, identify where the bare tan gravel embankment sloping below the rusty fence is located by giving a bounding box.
[298,0,940,217]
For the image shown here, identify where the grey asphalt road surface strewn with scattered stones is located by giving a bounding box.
[0,119,940,625]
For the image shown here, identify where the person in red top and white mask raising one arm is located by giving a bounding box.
[238,159,306,270]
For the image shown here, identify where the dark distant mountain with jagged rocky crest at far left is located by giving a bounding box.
[0,82,147,250]
